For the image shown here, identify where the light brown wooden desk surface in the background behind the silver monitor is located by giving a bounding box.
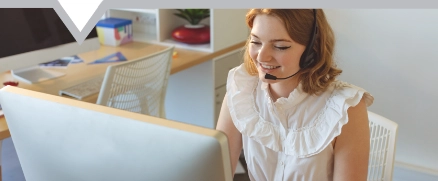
[0,42,245,140]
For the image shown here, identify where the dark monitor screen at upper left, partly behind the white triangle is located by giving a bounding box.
[0,8,97,57]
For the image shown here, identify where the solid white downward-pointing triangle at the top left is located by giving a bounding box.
[58,0,103,32]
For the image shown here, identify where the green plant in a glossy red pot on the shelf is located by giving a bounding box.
[172,9,210,44]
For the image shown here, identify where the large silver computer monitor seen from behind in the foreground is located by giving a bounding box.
[0,86,232,181]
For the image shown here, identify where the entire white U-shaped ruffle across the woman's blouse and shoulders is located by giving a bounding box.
[227,65,374,158]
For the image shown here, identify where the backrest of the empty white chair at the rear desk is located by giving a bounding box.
[97,46,174,118]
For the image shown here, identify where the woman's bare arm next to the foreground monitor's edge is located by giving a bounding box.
[216,94,242,175]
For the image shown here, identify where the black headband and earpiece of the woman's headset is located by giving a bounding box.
[300,9,318,69]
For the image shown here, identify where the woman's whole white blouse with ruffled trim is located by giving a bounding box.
[227,64,374,181]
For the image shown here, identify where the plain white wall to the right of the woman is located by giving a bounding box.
[325,9,438,174]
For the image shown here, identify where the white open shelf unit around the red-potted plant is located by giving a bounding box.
[107,8,248,52]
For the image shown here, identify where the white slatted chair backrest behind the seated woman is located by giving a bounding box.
[367,111,398,181]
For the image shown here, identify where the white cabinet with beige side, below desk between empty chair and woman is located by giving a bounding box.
[165,46,243,129]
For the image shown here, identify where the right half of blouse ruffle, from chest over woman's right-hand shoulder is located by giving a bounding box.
[283,81,374,158]
